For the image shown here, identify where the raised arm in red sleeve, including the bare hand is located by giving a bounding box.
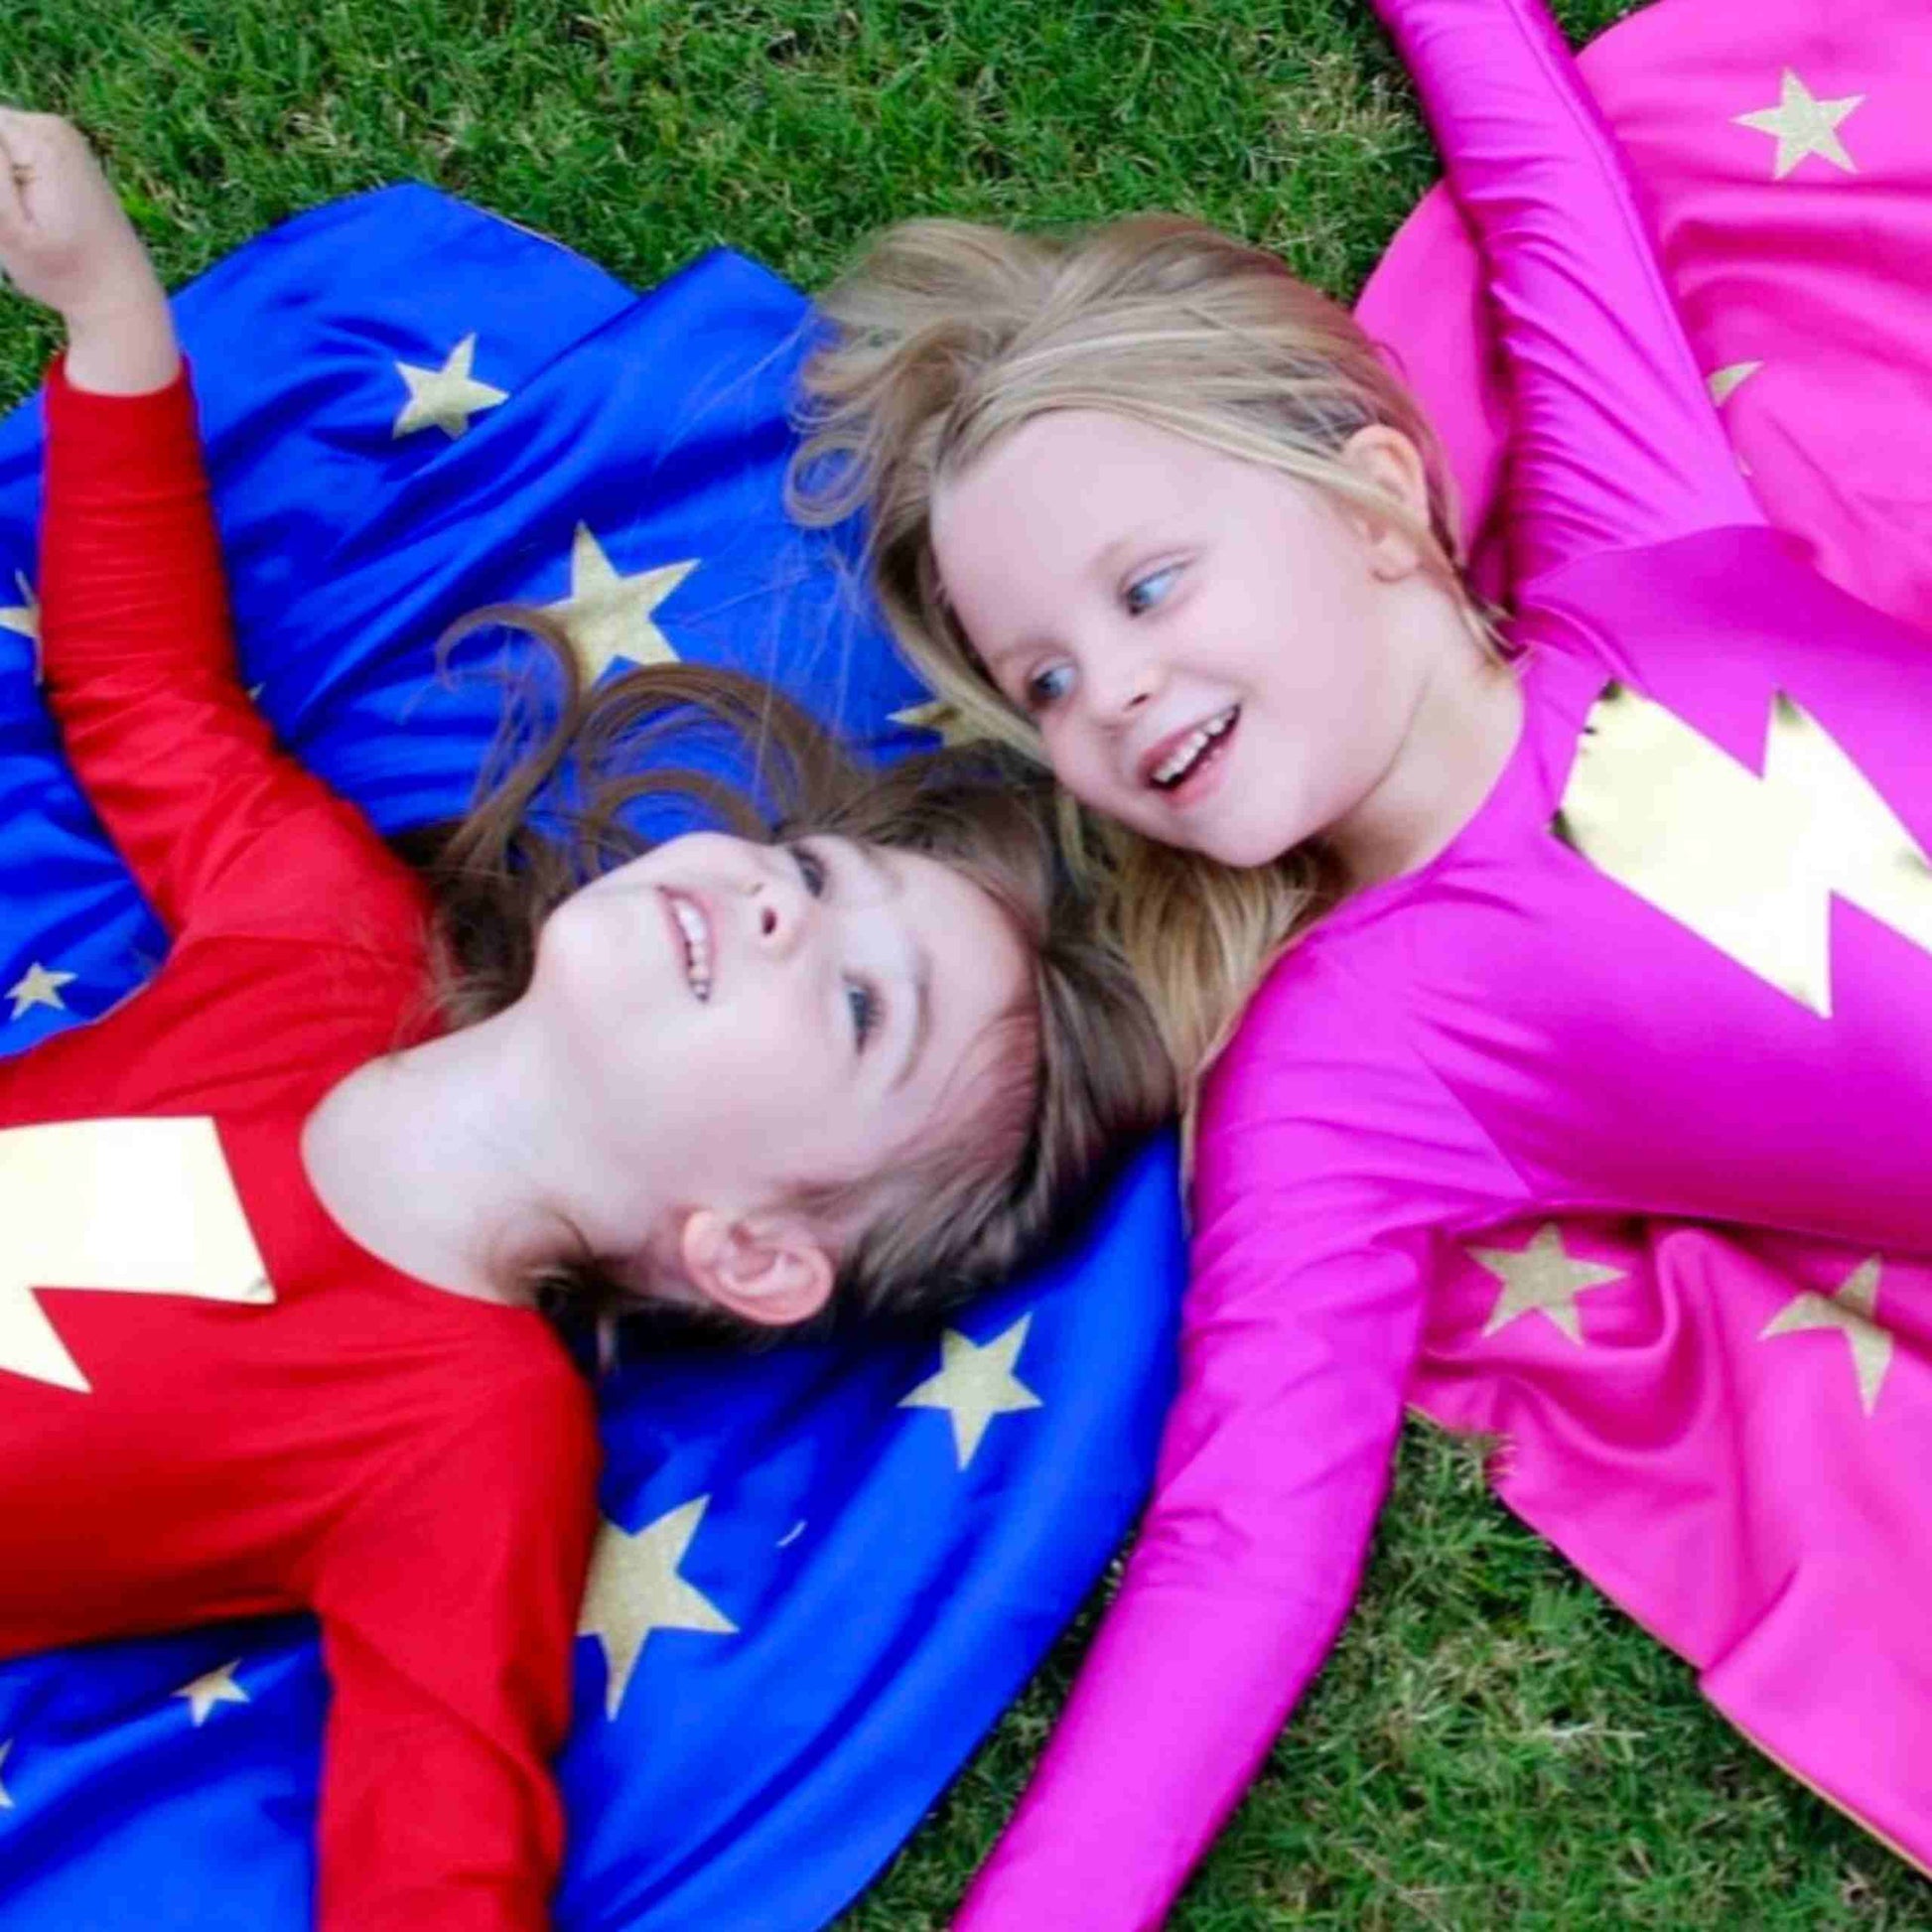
[0,110,392,931]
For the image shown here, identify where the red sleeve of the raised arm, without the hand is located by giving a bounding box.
[41,363,404,933]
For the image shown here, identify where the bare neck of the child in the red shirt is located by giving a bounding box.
[302,1007,656,1306]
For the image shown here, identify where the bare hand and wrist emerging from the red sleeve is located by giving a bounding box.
[0,108,178,394]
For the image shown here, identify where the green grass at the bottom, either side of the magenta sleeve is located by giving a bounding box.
[842,1424,1932,1932]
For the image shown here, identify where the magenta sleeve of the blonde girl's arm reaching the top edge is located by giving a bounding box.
[1376,0,1764,584]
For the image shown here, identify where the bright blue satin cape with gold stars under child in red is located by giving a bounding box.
[0,188,1182,1932]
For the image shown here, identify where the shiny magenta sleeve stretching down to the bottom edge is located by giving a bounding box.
[956,952,1521,1932]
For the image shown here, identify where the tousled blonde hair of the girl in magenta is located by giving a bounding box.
[788,214,1493,1080]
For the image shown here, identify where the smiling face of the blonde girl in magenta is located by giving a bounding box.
[933,410,1420,866]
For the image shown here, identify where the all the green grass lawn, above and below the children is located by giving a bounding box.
[0,0,1932,1932]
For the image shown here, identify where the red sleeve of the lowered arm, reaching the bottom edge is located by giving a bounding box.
[303,1377,597,1932]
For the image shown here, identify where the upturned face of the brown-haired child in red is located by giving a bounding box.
[525,833,1030,1298]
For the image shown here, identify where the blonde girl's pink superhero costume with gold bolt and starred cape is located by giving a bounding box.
[958,0,1932,1932]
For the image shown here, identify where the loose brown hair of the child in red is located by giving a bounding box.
[398,607,1173,1327]
